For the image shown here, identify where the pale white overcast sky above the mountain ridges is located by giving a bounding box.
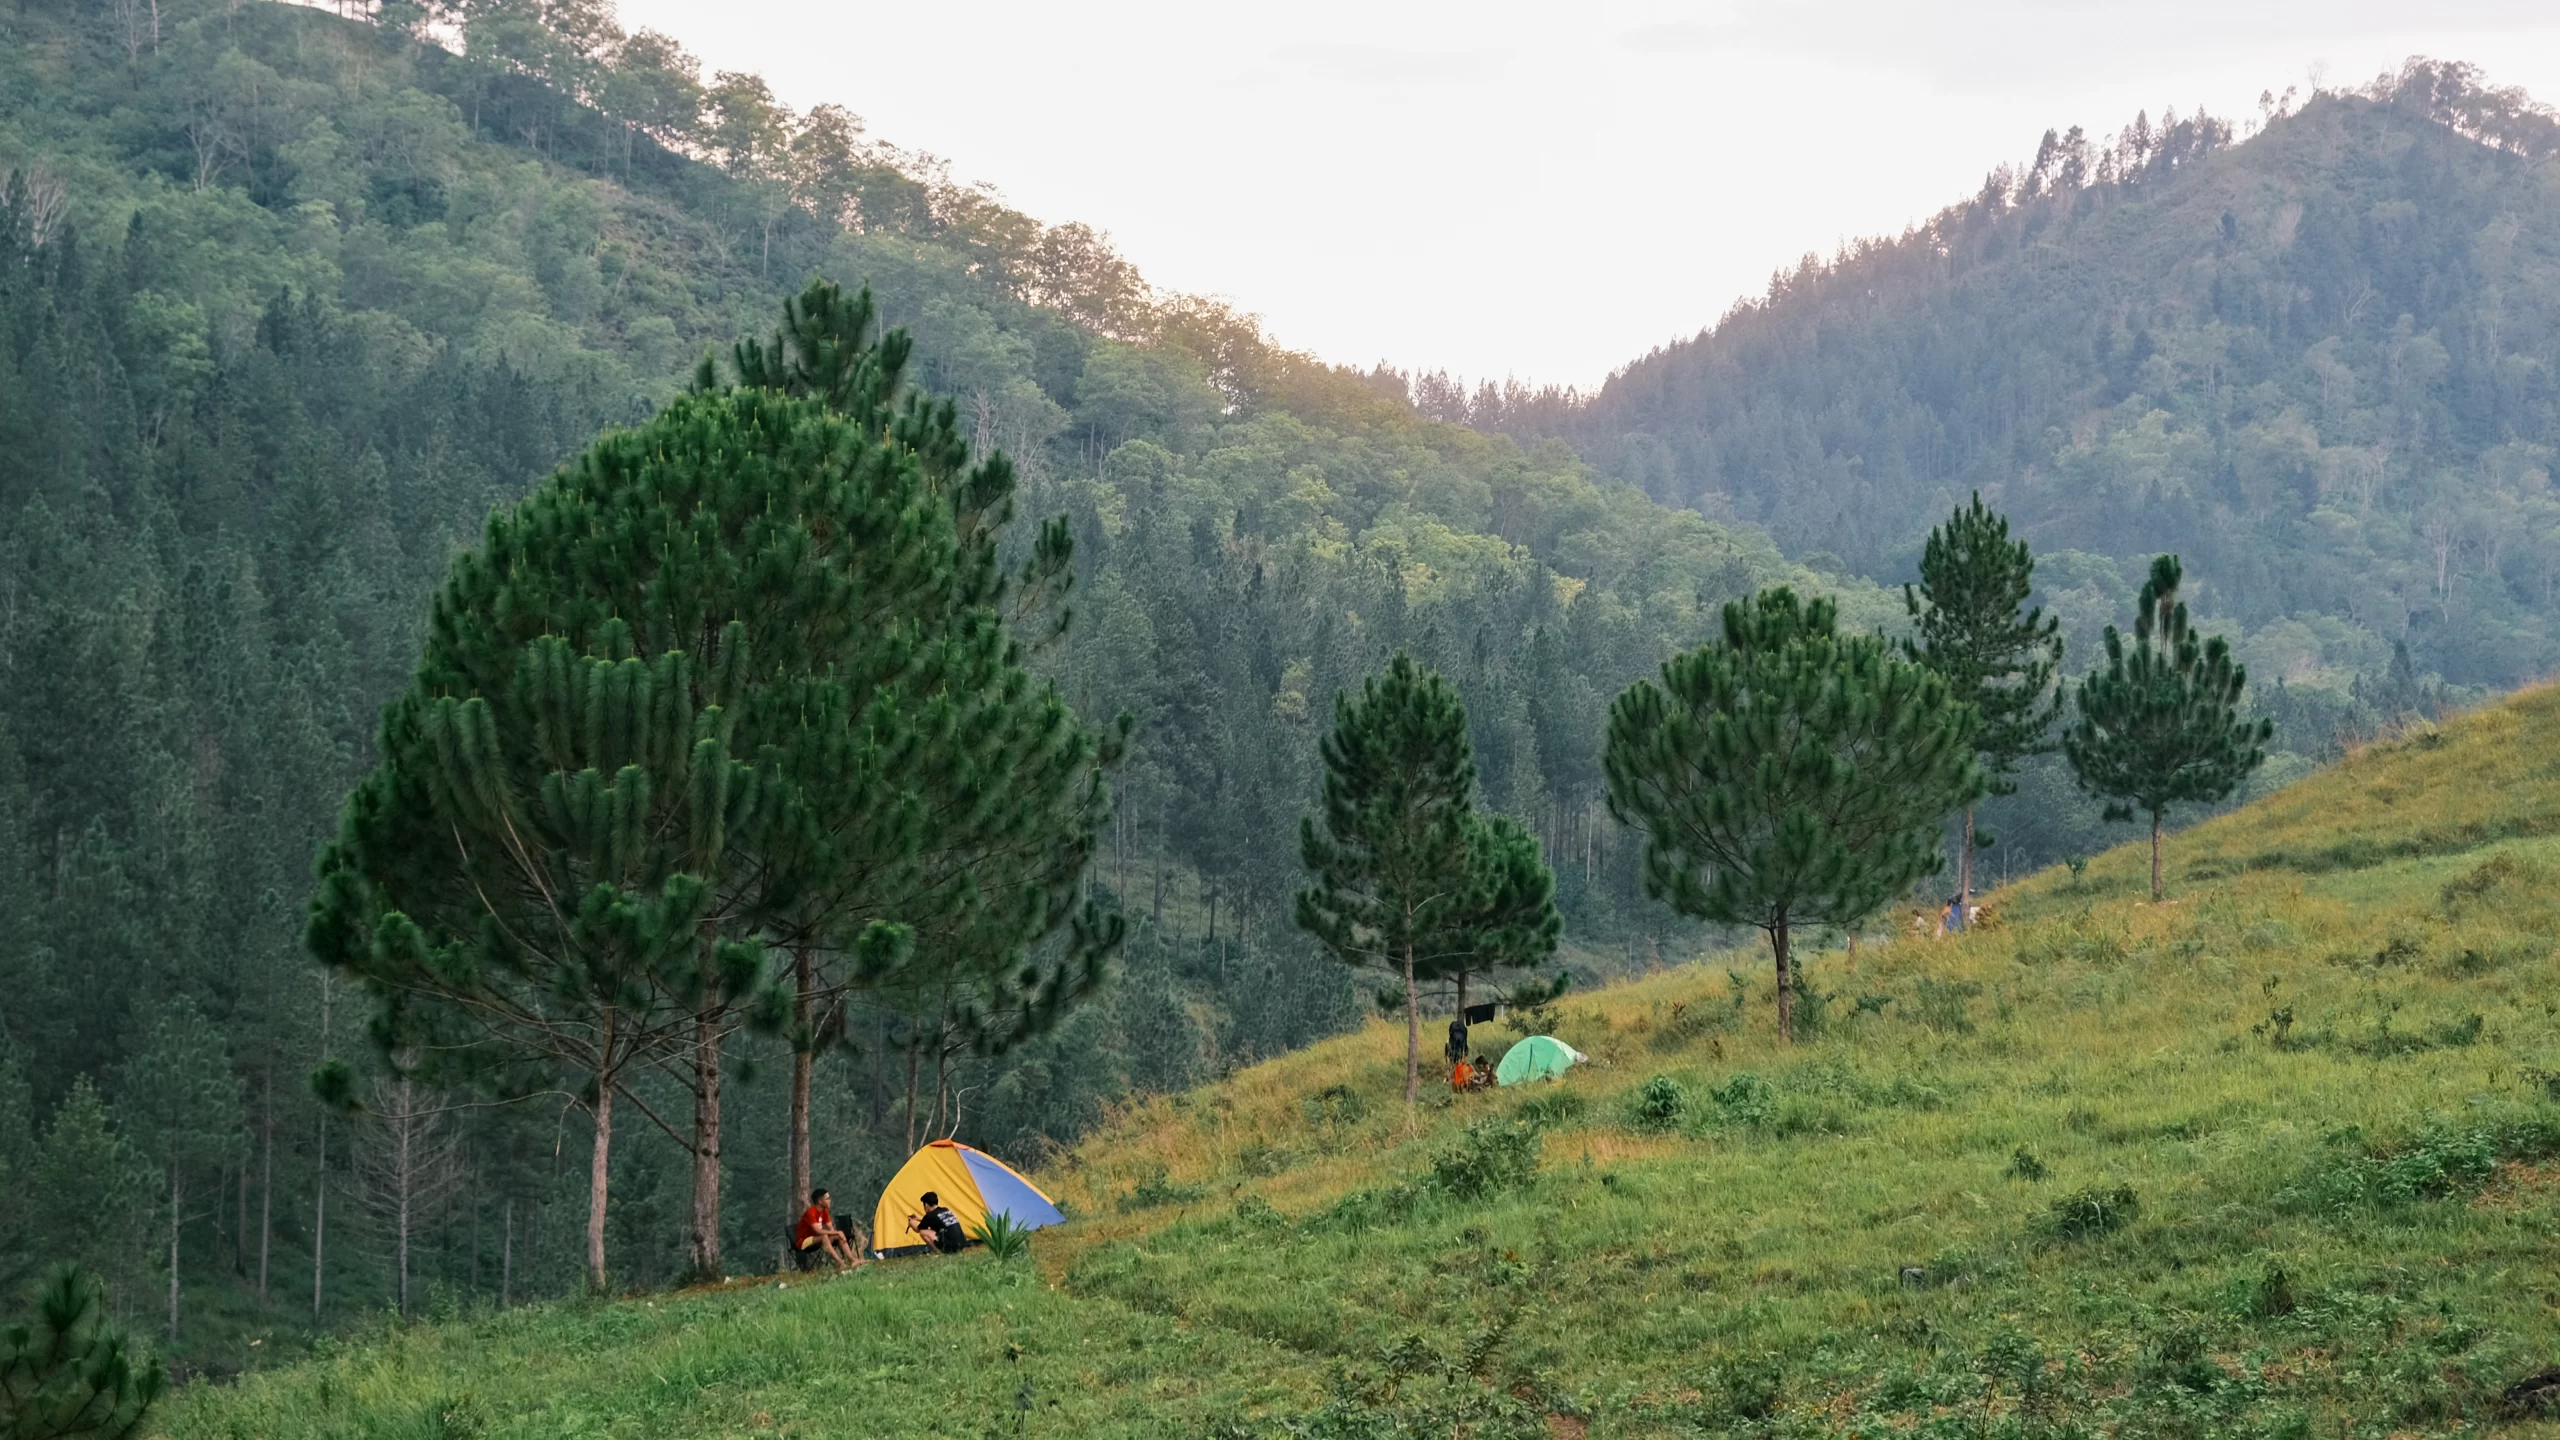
[622,0,2560,387]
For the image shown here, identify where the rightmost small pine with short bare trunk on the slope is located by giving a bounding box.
[2063,556,2276,899]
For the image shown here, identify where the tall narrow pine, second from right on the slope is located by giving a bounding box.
[1902,489,2063,925]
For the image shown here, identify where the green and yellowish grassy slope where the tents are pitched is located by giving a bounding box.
[169,689,2560,1435]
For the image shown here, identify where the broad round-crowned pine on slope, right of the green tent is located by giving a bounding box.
[1605,587,1981,1038]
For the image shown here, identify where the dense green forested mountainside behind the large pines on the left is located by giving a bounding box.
[0,0,1863,1366]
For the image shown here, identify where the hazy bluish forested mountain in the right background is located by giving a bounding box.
[1495,61,2560,707]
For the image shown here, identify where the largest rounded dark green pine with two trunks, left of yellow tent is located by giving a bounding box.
[312,353,1098,1284]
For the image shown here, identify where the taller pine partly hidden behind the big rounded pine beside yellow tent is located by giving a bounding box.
[694,279,1129,1194]
